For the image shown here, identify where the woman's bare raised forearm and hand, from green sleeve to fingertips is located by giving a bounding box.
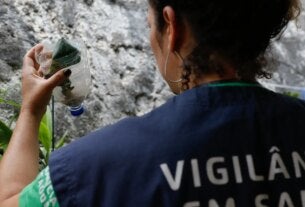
[0,45,71,207]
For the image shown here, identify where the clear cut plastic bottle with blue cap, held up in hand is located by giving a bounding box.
[35,38,91,116]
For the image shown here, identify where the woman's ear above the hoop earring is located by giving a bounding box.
[163,6,178,52]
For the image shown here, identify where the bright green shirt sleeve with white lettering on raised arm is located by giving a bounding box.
[19,167,59,207]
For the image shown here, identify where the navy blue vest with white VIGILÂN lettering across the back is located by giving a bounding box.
[50,84,305,207]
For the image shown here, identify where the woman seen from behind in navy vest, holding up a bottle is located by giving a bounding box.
[0,0,305,207]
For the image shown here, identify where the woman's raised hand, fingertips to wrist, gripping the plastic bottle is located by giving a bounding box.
[21,44,71,120]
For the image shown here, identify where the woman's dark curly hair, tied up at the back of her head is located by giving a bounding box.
[149,0,300,80]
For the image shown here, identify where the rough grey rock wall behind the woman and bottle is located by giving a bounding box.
[0,0,305,141]
